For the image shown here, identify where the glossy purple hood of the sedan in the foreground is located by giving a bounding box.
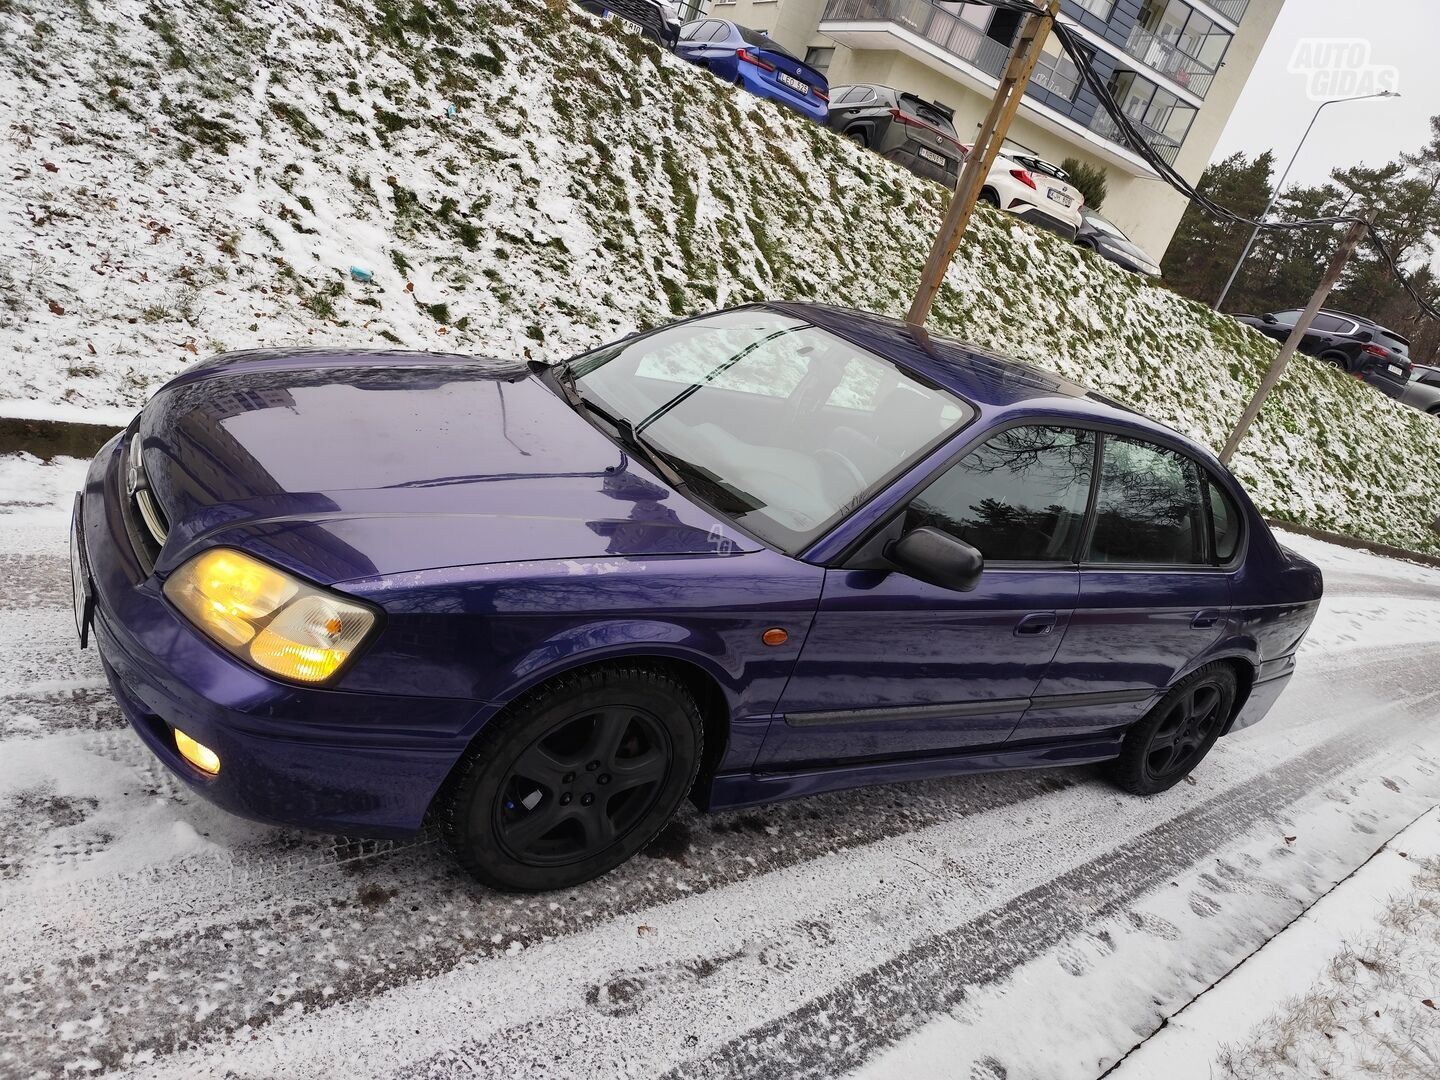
[137,351,757,583]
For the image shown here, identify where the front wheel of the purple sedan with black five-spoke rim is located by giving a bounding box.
[441,665,703,891]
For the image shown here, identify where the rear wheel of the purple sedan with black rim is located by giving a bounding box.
[1110,664,1236,795]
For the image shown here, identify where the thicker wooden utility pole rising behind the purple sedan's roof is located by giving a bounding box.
[906,0,1060,327]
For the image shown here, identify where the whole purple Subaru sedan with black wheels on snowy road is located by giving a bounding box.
[72,304,1320,890]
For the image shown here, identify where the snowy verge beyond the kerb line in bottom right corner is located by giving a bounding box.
[1113,809,1440,1080]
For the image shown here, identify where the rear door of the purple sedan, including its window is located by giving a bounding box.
[1014,433,1237,740]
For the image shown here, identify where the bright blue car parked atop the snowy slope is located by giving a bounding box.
[675,19,829,124]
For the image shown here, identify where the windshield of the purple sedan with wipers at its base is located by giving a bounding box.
[570,308,973,553]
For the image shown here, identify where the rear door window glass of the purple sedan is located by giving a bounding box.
[1086,435,1208,566]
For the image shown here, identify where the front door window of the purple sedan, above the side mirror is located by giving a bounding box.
[904,426,1096,563]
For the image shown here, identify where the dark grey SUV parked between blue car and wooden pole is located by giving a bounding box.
[825,85,965,187]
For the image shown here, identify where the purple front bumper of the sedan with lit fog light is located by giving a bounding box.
[78,435,480,837]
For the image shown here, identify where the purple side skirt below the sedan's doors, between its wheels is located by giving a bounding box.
[696,729,1125,811]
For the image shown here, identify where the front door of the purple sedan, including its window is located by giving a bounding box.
[757,425,1096,770]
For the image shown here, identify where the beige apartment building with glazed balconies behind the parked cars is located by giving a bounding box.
[708,0,1284,258]
